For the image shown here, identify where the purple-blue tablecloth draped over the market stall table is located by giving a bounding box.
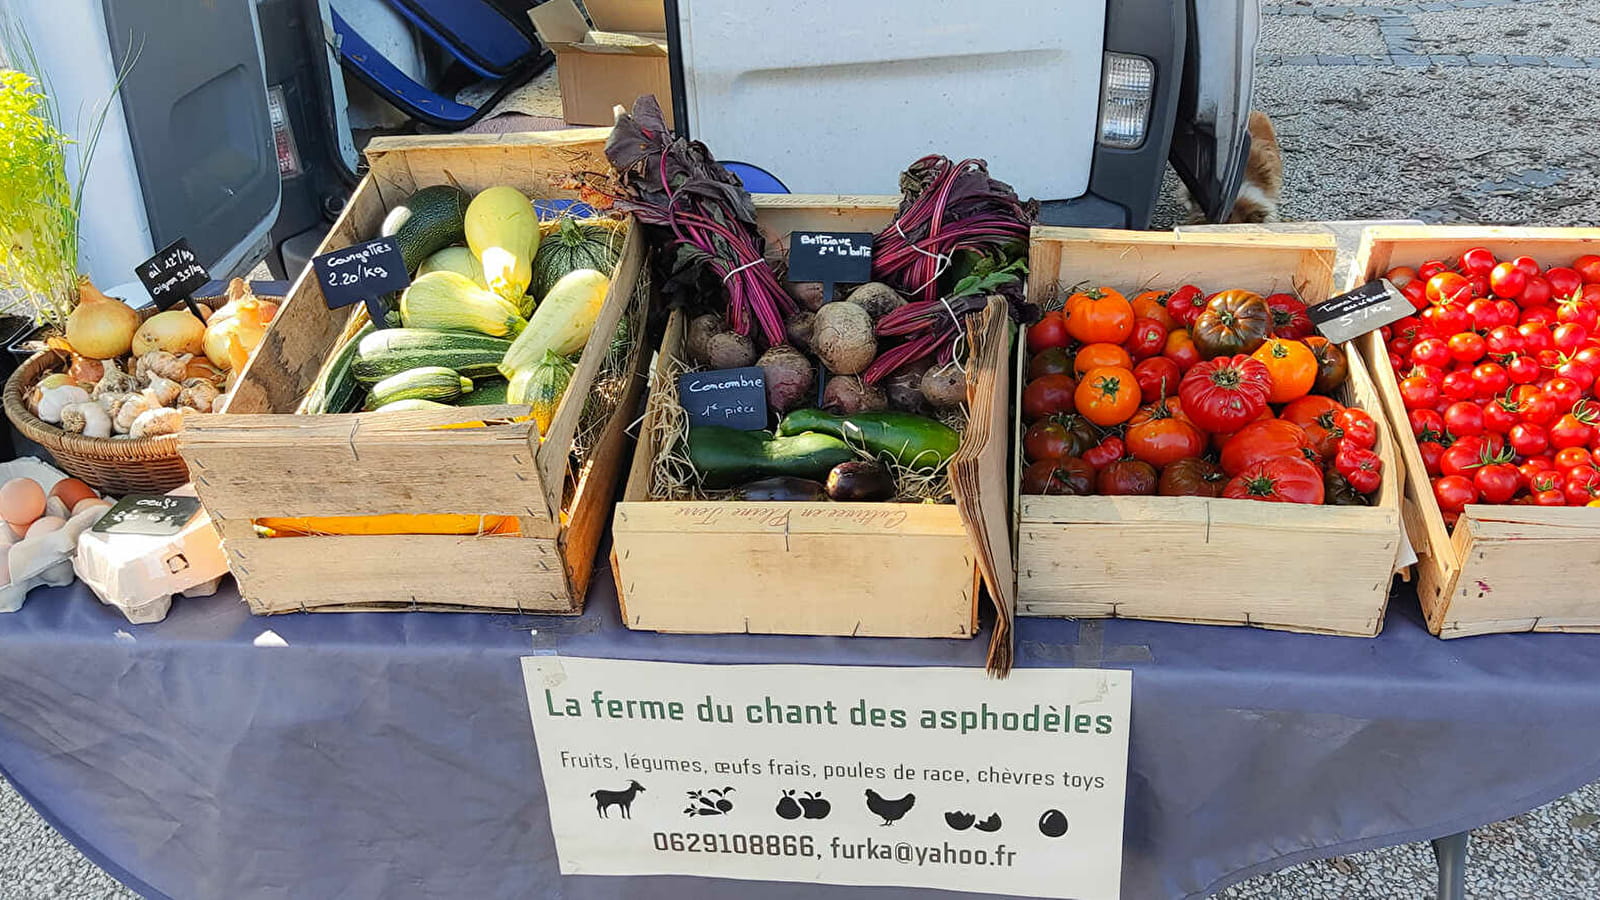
[0,566,1600,900]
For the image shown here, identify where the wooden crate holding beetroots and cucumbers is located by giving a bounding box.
[611,195,1011,642]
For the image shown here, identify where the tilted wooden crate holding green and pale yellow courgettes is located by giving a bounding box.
[181,128,648,613]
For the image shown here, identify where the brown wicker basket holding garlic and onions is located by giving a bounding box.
[5,351,189,493]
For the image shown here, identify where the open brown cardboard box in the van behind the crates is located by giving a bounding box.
[528,0,672,125]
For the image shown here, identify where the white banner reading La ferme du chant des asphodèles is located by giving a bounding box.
[523,657,1133,900]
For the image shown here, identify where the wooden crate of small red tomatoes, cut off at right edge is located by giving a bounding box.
[1350,226,1600,637]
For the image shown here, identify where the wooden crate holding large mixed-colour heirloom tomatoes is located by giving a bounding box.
[1014,227,1402,636]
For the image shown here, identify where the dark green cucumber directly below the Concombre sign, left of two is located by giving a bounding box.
[688,424,856,488]
